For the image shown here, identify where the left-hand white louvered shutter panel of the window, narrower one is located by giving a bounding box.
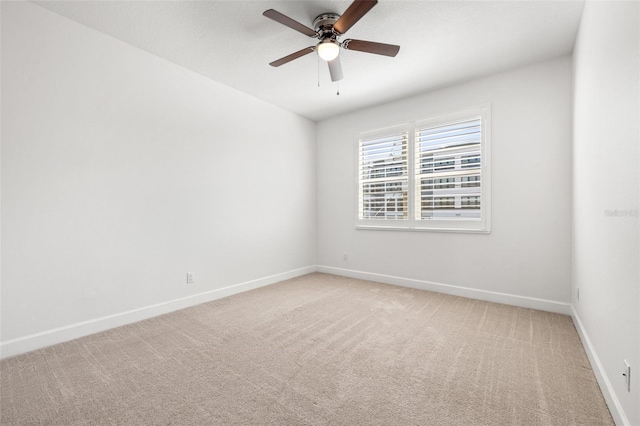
[358,131,409,220]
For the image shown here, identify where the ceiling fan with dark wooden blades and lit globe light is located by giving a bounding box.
[263,0,400,81]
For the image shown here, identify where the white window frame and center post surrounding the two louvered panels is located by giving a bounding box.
[355,104,491,234]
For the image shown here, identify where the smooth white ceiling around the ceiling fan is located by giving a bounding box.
[34,0,584,121]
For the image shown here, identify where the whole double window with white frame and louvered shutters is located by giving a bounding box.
[356,105,490,232]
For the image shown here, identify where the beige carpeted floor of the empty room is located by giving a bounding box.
[0,274,613,426]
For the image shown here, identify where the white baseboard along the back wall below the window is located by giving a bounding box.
[316,265,571,315]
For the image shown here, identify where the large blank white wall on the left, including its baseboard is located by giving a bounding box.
[1,2,315,356]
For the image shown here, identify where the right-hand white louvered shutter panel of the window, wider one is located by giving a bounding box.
[414,117,482,220]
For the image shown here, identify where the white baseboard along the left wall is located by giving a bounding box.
[0,266,316,359]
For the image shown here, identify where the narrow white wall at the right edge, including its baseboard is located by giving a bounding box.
[573,1,640,425]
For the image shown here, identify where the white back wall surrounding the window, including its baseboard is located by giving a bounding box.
[317,57,571,313]
